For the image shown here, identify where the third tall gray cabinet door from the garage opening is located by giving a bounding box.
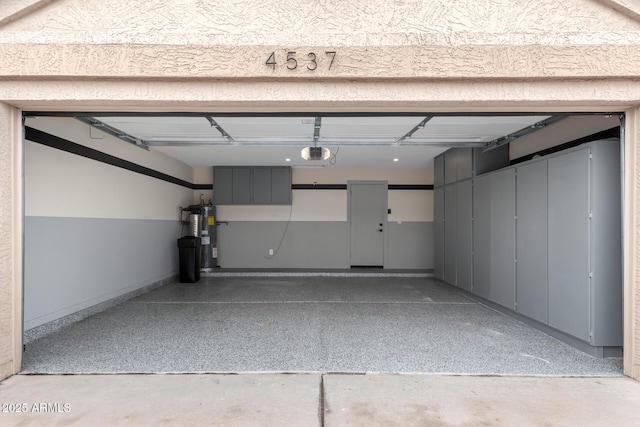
[490,169,516,310]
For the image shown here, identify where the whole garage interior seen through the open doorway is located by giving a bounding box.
[23,112,624,376]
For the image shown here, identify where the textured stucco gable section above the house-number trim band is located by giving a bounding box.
[2,0,638,45]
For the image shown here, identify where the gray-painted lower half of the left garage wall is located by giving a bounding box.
[24,217,181,330]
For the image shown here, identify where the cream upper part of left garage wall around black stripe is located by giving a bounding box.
[24,118,193,222]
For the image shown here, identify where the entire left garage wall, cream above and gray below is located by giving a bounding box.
[24,118,193,336]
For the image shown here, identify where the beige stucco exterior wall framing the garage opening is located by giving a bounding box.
[0,0,640,379]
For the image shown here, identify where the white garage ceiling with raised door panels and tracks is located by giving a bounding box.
[84,114,558,168]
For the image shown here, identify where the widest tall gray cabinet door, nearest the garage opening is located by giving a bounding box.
[548,149,589,341]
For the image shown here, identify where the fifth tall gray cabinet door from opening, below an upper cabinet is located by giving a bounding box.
[456,180,473,292]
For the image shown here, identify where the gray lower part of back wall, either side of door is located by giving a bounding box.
[218,221,433,269]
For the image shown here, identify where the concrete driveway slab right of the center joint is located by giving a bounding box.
[323,375,640,427]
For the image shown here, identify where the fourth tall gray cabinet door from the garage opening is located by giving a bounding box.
[473,175,491,299]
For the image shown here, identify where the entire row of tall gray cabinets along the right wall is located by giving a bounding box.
[435,139,623,356]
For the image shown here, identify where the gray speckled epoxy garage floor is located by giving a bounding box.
[23,277,622,376]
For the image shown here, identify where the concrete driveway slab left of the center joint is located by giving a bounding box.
[0,374,320,427]
